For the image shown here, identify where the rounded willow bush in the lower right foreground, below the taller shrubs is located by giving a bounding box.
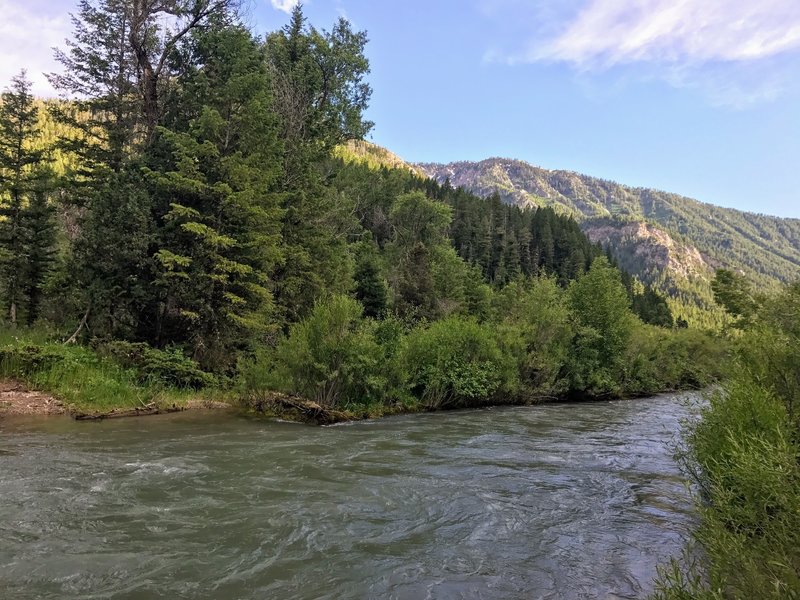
[654,378,800,600]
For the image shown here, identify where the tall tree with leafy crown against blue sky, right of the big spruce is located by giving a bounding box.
[265,6,372,323]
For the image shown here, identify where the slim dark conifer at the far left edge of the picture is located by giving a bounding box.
[0,71,44,325]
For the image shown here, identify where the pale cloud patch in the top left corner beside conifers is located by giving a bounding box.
[0,0,70,96]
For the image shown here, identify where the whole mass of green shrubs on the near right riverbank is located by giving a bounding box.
[654,285,800,600]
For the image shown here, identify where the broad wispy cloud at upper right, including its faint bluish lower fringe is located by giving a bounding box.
[490,0,800,108]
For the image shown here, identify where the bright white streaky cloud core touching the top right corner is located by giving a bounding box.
[536,0,800,68]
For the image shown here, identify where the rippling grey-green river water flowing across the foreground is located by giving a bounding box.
[0,396,692,600]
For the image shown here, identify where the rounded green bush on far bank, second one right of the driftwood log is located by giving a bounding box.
[401,317,518,409]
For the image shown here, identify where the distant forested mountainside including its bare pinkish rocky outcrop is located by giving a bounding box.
[417,158,800,287]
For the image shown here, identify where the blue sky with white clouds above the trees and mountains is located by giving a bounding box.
[0,0,800,218]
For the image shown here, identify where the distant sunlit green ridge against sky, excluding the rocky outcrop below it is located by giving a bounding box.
[419,158,800,281]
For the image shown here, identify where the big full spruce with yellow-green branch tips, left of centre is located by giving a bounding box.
[142,25,282,369]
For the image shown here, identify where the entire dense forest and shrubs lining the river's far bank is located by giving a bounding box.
[0,0,725,412]
